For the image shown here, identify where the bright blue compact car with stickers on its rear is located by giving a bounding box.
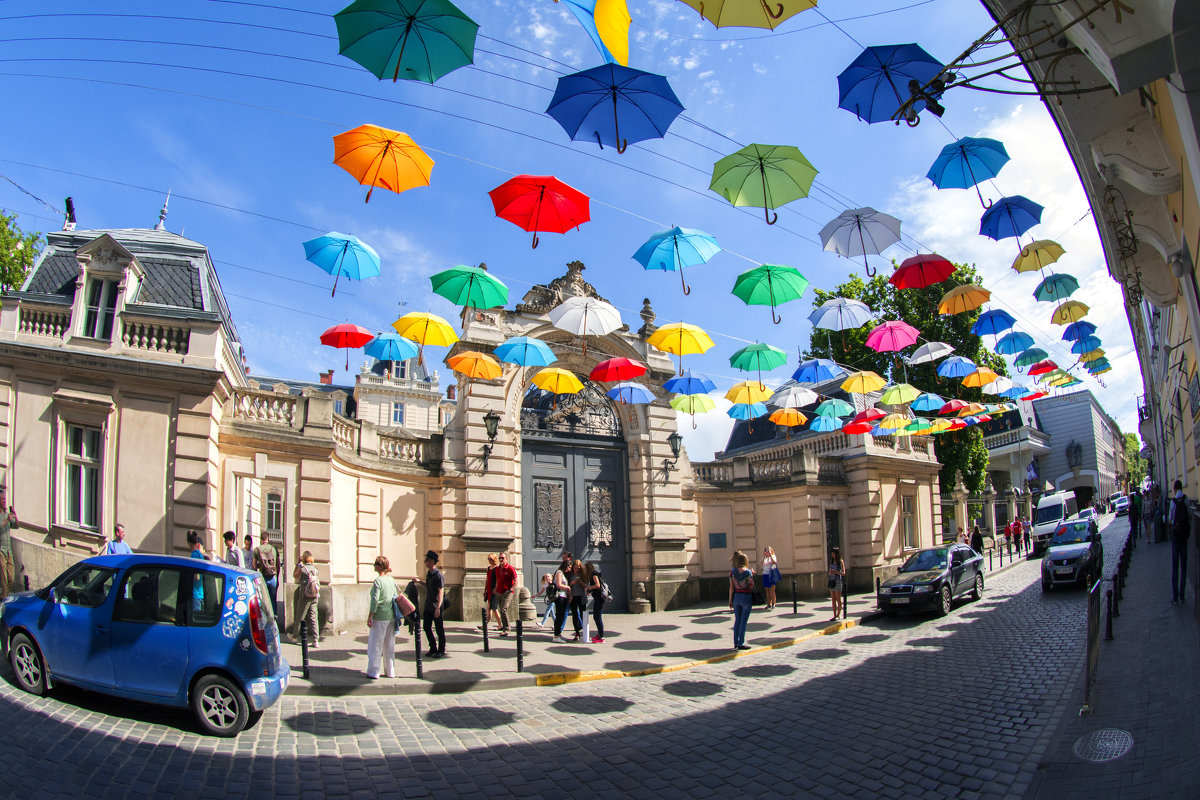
[0,554,290,736]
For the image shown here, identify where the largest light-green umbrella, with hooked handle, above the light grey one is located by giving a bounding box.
[708,144,817,225]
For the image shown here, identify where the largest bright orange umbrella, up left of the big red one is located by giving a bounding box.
[334,125,433,200]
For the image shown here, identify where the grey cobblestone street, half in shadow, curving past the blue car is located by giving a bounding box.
[0,524,1161,800]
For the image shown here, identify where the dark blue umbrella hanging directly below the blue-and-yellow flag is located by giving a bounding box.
[546,64,683,152]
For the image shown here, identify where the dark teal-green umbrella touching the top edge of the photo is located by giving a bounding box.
[334,0,479,83]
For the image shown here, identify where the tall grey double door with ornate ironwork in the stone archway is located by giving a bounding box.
[521,384,629,609]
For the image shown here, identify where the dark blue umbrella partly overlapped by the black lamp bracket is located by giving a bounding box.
[838,44,943,124]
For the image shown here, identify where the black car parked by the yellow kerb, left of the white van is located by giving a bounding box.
[877,545,983,616]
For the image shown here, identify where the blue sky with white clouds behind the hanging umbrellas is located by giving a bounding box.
[0,0,1144,459]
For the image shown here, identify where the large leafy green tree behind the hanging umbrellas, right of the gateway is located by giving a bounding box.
[806,265,1008,493]
